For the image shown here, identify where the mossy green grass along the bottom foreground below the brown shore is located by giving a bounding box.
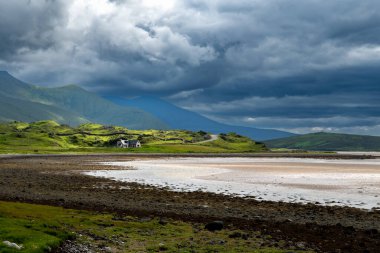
[0,202,312,253]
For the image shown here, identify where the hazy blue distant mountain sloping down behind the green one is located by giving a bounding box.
[105,96,294,141]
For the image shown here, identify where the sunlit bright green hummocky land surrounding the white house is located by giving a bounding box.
[0,121,266,153]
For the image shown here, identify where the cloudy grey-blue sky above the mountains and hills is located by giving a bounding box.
[0,0,380,135]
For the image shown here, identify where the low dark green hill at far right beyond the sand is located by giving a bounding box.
[265,133,380,151]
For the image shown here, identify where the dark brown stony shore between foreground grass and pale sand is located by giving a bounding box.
[0,155,380,252]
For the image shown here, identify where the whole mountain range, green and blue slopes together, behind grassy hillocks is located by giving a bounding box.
[0,71,294,141]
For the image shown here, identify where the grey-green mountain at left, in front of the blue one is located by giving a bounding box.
[0,71,168,129]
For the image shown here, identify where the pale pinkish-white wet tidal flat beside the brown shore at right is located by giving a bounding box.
[85,158,380,209]
